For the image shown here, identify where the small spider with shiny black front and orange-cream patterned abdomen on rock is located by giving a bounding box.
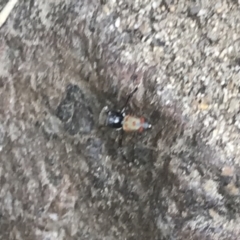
[99,88,152,132]
